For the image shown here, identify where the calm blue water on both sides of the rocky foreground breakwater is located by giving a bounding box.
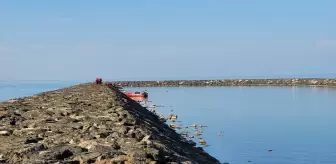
[0,82,336,164]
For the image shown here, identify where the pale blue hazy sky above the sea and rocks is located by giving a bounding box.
[0,0,336,81]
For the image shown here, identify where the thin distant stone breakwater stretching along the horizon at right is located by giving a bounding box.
[112,78,336,87]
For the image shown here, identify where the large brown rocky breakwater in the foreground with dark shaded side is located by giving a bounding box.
[0,84,219,164]
